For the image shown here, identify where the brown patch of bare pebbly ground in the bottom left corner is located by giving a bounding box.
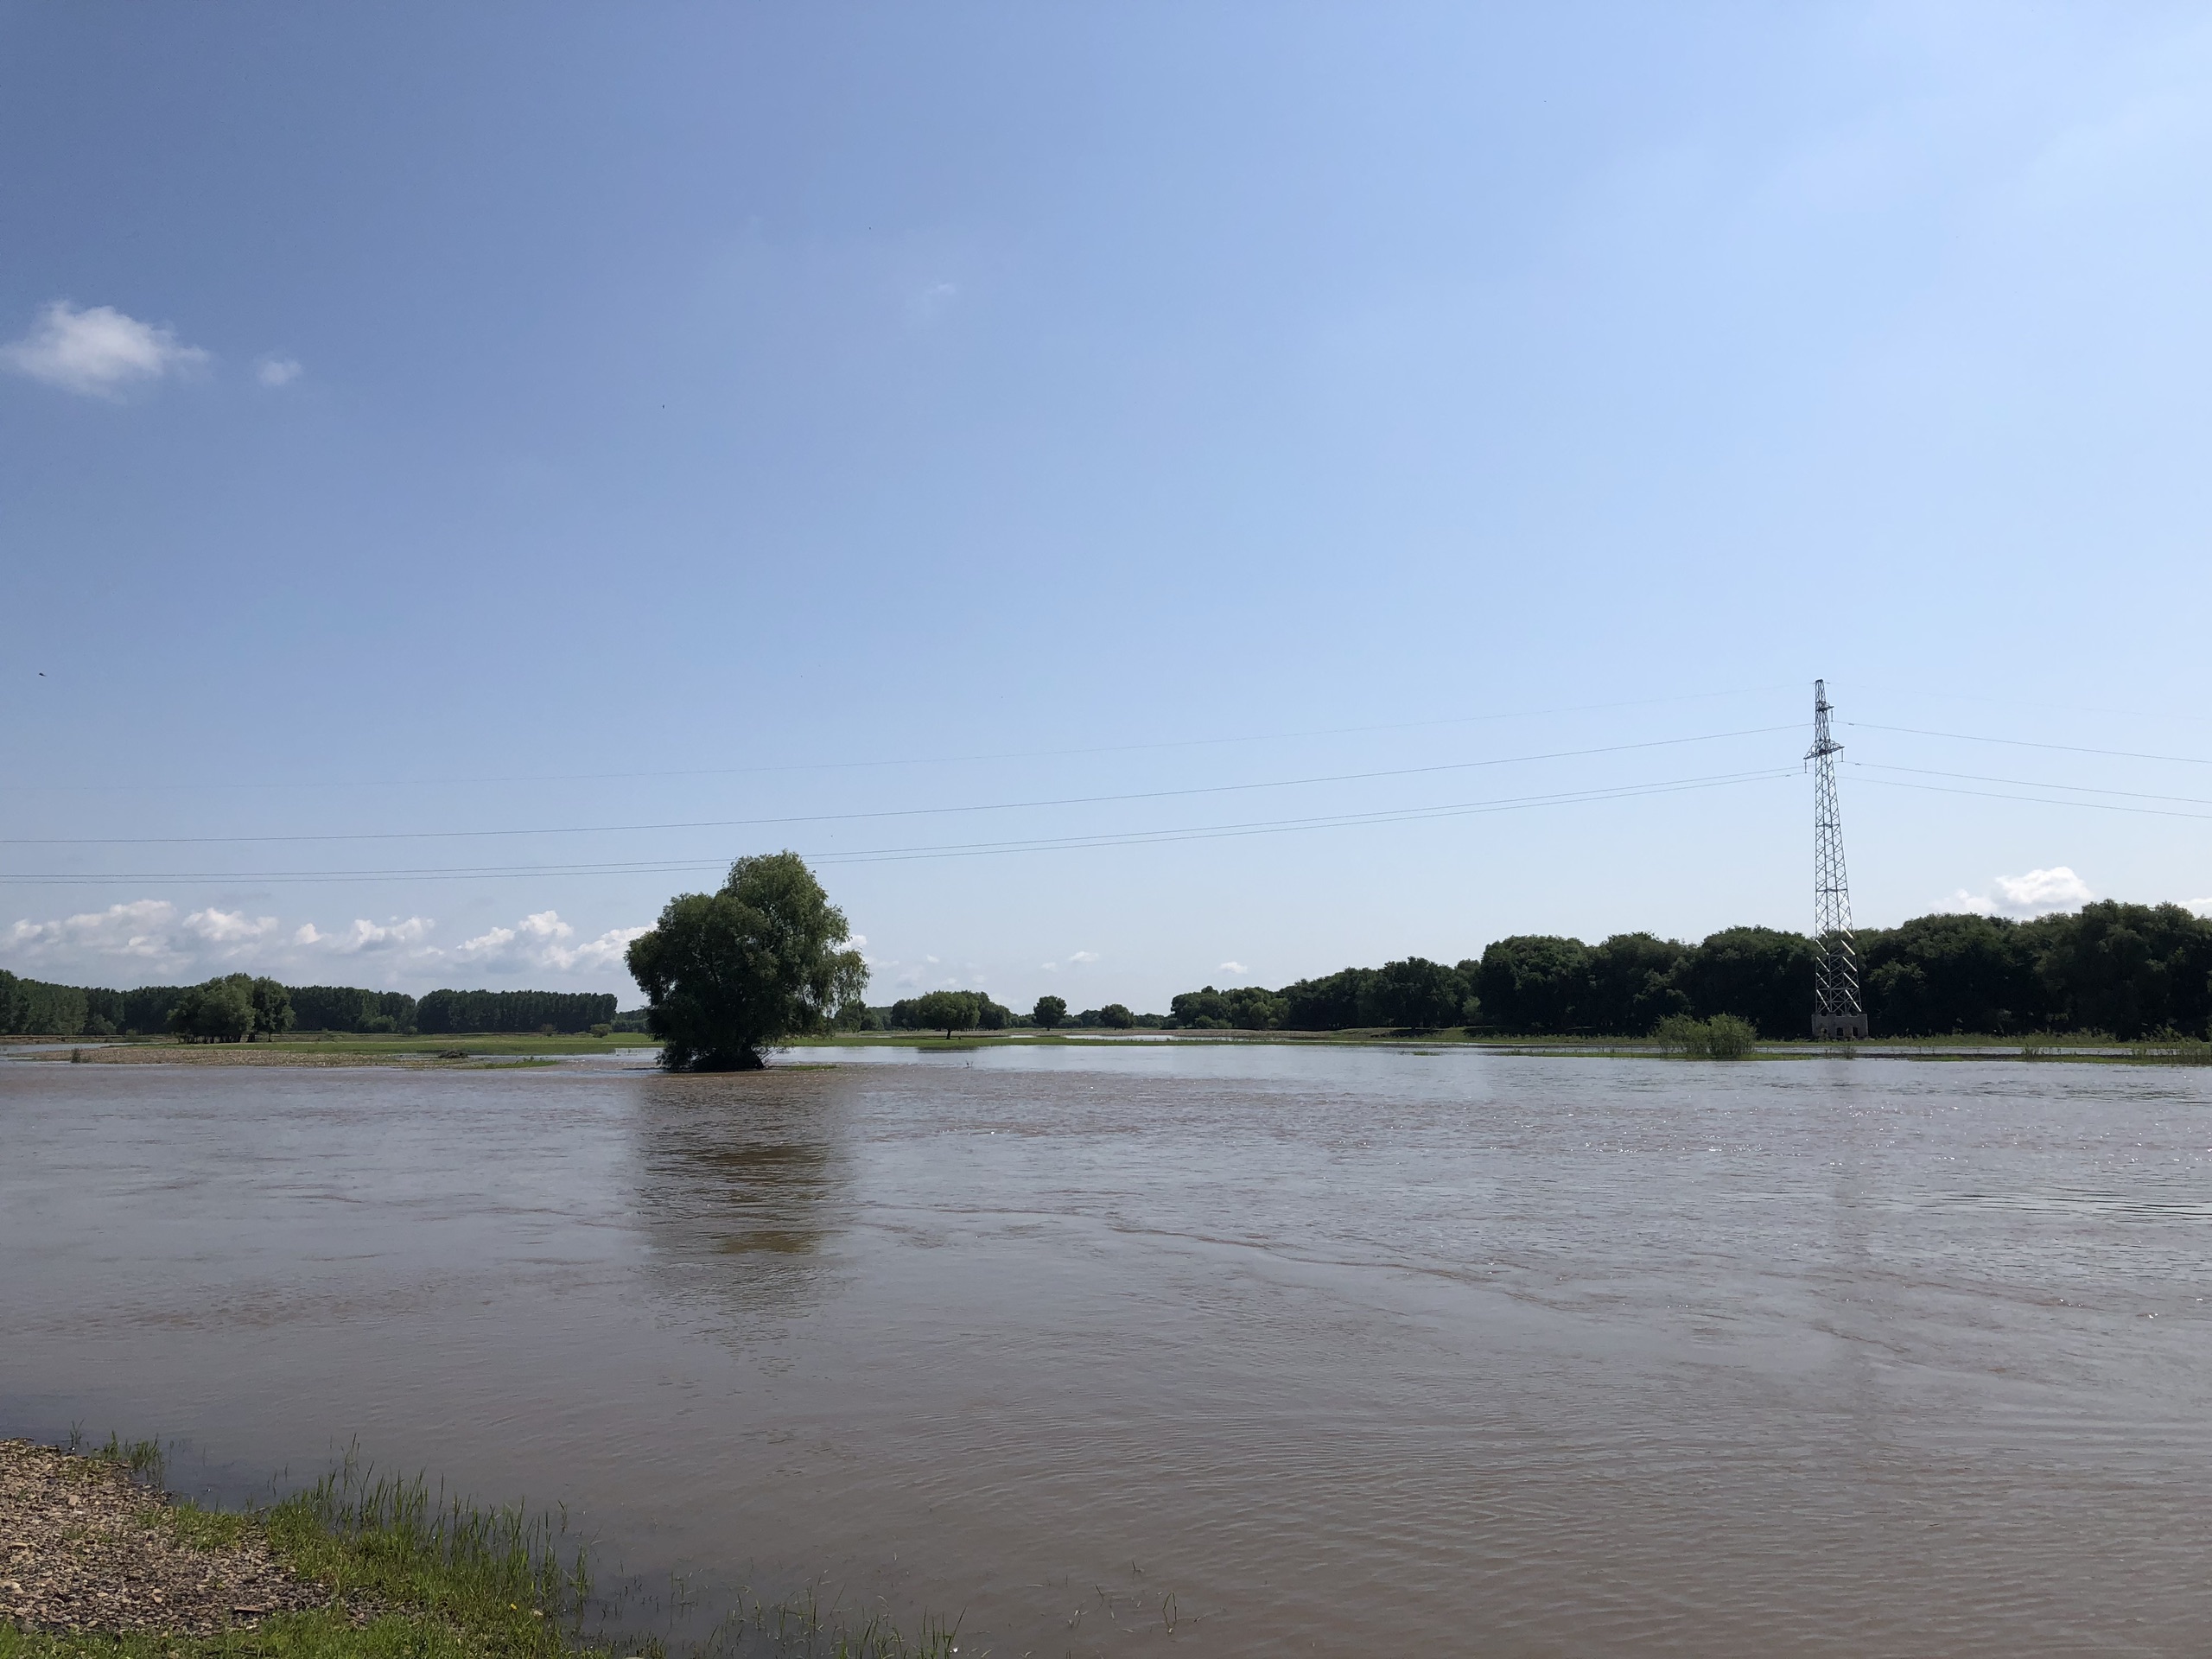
[0,1440,332,1637]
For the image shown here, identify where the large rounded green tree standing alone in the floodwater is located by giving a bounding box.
[631,852,868,1071]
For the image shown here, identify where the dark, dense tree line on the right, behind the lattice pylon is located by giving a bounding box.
[1168,902,2212,1039]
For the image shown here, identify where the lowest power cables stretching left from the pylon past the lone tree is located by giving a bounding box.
[0,767,1796,887]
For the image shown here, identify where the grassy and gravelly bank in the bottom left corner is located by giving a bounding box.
[0,1440,957,1659]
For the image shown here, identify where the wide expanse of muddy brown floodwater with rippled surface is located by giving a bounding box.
[0,1046,2212,1659]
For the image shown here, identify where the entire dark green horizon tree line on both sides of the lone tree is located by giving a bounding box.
[13,902,2212,1042]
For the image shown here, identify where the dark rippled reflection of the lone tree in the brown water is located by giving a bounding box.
[637,1071,849,1314]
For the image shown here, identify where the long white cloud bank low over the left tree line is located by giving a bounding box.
[0,898,648,991]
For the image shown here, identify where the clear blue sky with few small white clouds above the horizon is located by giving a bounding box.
[0,4,2212,1007]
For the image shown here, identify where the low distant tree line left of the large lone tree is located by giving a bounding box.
[0,969,615,1042]
